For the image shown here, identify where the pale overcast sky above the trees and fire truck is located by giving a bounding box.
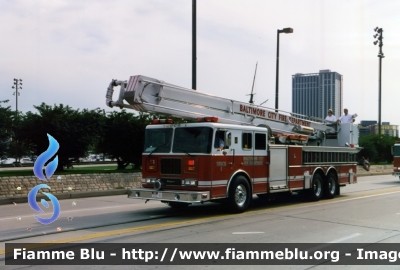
[0,0,400,125]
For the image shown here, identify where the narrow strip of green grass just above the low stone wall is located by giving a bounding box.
[0,165,142,177]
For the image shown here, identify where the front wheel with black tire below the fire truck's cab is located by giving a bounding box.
[228,176,252,213]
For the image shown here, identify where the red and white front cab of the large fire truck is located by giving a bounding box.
[128,119,268,213]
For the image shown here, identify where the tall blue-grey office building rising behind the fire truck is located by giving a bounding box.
[292,69,343,119]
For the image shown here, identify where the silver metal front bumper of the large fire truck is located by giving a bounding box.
[128,188,210,204]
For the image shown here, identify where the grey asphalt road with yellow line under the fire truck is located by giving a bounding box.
[0,175,400,270]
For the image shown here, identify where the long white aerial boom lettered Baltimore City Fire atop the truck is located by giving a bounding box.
[106,75,354,145]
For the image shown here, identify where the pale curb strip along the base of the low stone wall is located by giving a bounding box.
[0,189,128,205]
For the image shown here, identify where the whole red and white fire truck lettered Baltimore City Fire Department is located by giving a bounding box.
[106,75,360,212]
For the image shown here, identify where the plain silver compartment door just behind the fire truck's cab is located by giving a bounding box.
[269,147,288,191]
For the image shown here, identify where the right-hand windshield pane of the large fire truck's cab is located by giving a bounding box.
[172,127,213,154]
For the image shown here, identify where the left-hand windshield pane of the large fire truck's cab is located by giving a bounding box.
[144,128,172,153]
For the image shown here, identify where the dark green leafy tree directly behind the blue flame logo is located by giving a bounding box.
[20,103,105,171]
